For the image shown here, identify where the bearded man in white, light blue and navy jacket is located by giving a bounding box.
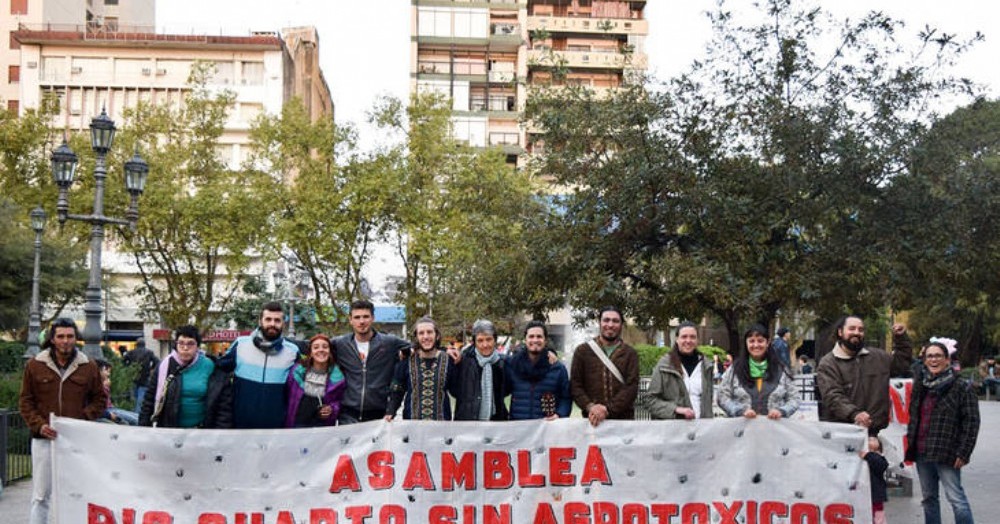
[216,302,299,429]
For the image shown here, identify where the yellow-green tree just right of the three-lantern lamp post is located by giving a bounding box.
[110,63,279,328]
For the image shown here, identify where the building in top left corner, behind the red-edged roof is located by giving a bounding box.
[0,0,156,111]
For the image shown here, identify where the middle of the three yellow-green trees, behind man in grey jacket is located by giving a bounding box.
[250,100,391,322]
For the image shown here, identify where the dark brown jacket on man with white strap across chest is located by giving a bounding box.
[569,342,639,420]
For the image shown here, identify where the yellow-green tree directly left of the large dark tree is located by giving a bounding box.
[379,95,532,326]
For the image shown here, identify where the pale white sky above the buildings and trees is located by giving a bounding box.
[156,0,1000,143]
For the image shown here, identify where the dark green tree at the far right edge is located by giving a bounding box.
[879,100,1000,366]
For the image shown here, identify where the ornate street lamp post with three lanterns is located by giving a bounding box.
[52,109,149,359]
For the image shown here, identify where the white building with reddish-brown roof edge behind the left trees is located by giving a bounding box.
[13,24,333,343]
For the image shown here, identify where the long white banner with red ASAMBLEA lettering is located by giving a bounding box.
[53,418,871,524]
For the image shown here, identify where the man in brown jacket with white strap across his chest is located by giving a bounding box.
[570,306,639,426]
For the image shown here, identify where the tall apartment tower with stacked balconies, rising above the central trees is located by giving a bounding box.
[410,0,649,164]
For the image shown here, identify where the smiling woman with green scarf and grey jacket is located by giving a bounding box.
[718,324,799,420]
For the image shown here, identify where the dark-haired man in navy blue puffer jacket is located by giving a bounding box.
[507,320,573,420]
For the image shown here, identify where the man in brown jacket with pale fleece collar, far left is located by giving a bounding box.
[19,318,107,524]
